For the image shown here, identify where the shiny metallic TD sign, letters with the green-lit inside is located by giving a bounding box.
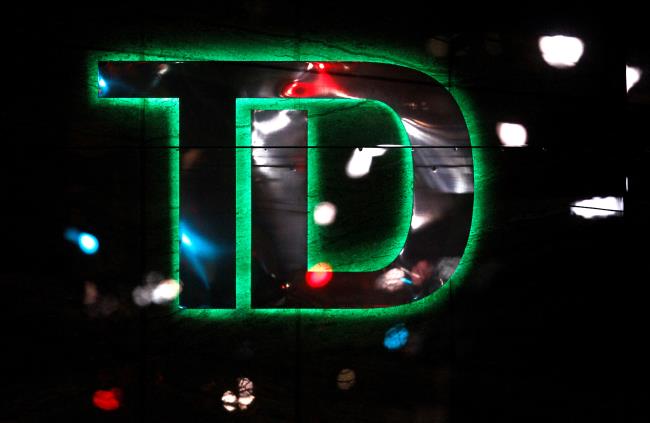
[98,61,474,309]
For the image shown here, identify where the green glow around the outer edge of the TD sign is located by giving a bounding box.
[87,36,491,321]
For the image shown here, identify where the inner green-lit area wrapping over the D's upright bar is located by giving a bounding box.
[236,98,414,308]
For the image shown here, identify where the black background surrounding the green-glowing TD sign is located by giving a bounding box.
[0,1,650,422]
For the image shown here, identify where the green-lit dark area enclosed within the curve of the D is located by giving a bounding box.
[307,100,414,272]
